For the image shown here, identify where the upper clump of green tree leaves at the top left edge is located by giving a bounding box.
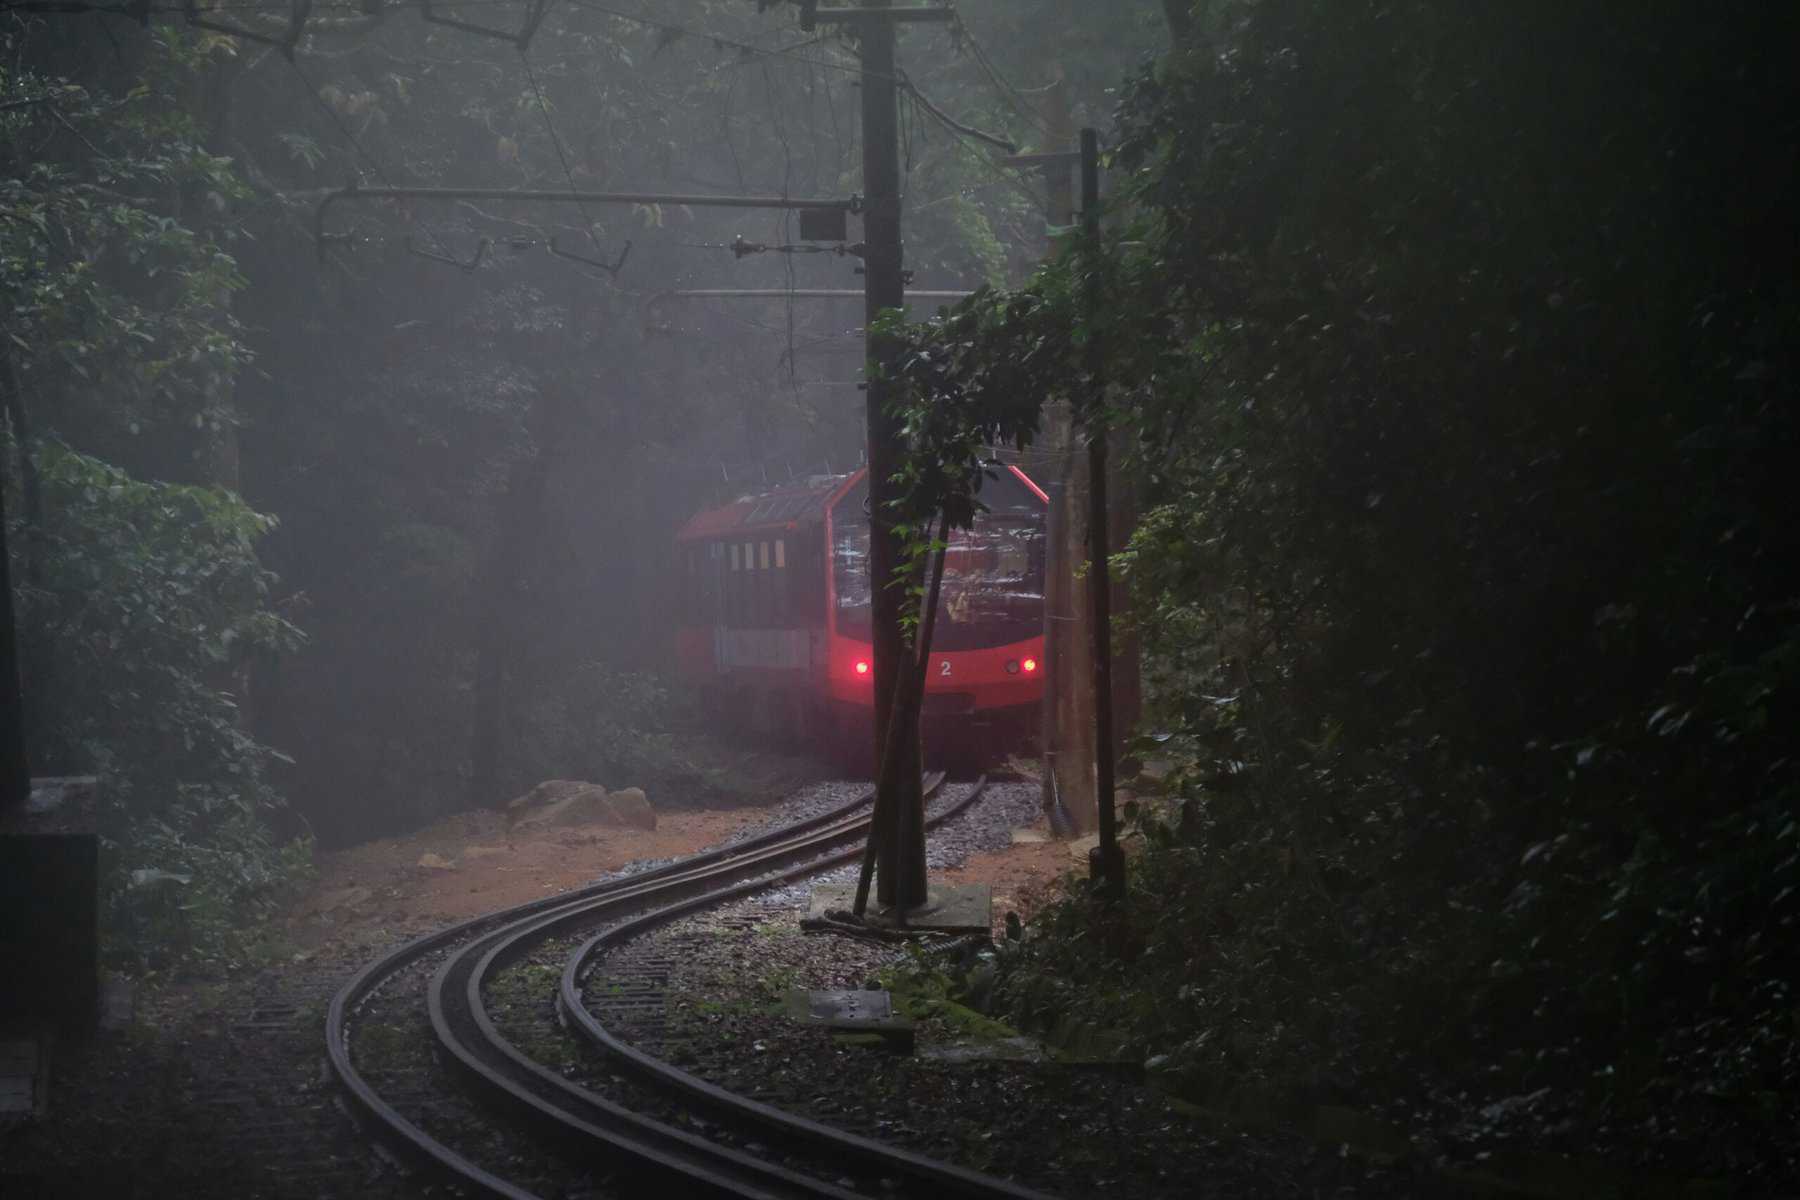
[0,41,248,457]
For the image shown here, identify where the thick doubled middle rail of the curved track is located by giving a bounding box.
[427,772,967,1200]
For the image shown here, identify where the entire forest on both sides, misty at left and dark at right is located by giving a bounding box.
[0,0,1800,1187]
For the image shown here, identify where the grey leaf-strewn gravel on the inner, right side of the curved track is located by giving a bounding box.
[590,783,1395,1196]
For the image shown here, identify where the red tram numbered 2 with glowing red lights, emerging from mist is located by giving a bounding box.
[675,466,1046,761]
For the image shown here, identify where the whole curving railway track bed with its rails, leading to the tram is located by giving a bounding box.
[326,774,1040,1200]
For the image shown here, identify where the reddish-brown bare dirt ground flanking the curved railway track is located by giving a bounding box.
[0,780,1073,1200]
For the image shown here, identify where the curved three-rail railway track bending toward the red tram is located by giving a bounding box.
[326,774,1042,1200]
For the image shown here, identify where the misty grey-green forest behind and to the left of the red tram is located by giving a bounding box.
[0,0,1165,954]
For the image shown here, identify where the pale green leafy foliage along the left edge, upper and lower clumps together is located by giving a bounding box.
[0,39,310,966]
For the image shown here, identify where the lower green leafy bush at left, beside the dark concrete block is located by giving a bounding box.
[9,443,306,964]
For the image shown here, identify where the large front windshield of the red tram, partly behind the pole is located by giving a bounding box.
[832,471,1044,651]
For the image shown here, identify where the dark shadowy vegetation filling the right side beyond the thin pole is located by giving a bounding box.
[885,0,1800,1180]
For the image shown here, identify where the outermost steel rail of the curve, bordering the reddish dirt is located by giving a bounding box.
[326,773,914,1200]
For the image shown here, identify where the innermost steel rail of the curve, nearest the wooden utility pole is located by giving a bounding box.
[561,777,1051,1200]
